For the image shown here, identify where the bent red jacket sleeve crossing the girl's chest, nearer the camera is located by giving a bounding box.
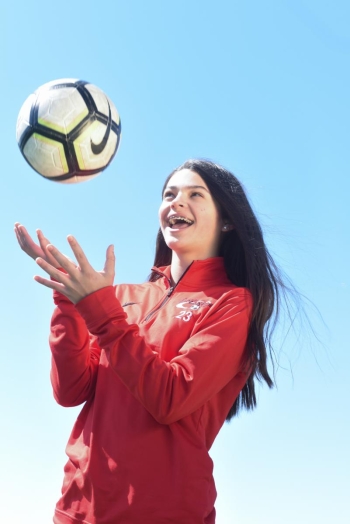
[75,286,252,424]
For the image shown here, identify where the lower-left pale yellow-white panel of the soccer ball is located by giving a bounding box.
[23,134,68,178]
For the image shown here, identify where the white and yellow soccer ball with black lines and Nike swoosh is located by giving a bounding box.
[16,78,121,183]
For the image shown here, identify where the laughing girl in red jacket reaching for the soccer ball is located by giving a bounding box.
[15,160,282,524]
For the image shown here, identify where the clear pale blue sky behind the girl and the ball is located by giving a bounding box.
[0,0,350,524]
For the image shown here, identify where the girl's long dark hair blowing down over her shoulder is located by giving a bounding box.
[149,160,293,420]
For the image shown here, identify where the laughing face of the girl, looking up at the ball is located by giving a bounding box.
[159,169,224,261]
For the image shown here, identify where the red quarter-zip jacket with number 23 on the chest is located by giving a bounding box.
[50,258,252,524]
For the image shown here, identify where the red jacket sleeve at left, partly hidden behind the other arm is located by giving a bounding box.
[50,292,101,407]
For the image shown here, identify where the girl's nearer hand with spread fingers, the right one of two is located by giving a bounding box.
[34,235,115,304]
